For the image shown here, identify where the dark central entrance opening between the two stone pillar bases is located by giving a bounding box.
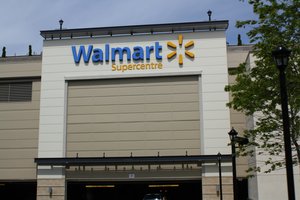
[67,181,202,200]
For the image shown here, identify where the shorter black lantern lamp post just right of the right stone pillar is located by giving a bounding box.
[228,128,249,200]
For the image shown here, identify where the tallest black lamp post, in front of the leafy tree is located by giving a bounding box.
[272,46,295,200]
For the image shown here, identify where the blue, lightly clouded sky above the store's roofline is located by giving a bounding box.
[0,0,256,56]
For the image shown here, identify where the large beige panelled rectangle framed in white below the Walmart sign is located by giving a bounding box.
[67,76,200,157]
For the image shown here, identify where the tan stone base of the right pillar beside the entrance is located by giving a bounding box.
[202,177,233,200]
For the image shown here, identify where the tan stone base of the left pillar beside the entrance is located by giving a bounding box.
[37,179,66,200]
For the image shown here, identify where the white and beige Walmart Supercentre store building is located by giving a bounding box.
[0,21,253,200]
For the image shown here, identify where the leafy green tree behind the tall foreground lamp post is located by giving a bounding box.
[225,0,300,173]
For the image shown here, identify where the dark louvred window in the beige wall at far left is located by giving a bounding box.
[0,81,32,102]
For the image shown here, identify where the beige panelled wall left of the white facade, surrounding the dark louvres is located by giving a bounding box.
[0,56,41,180]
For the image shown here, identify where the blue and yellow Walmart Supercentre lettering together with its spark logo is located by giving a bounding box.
[72,34,195,72]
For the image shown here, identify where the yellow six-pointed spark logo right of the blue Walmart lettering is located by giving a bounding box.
[167,35,195,65]
